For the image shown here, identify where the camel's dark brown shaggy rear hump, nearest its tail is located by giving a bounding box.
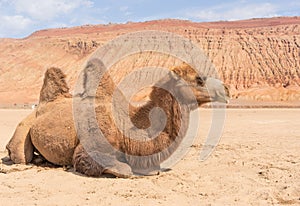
[40,67,71,103]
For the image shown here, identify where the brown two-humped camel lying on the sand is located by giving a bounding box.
[6,59,229,177]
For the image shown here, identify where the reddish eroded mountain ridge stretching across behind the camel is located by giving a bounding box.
[0,17,300,104]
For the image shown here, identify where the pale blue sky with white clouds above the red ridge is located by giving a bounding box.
[0,0,300,38]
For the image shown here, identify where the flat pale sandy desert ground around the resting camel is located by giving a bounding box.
[0,109,300,206]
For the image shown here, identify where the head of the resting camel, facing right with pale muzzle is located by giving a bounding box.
[171,64,230,109]
